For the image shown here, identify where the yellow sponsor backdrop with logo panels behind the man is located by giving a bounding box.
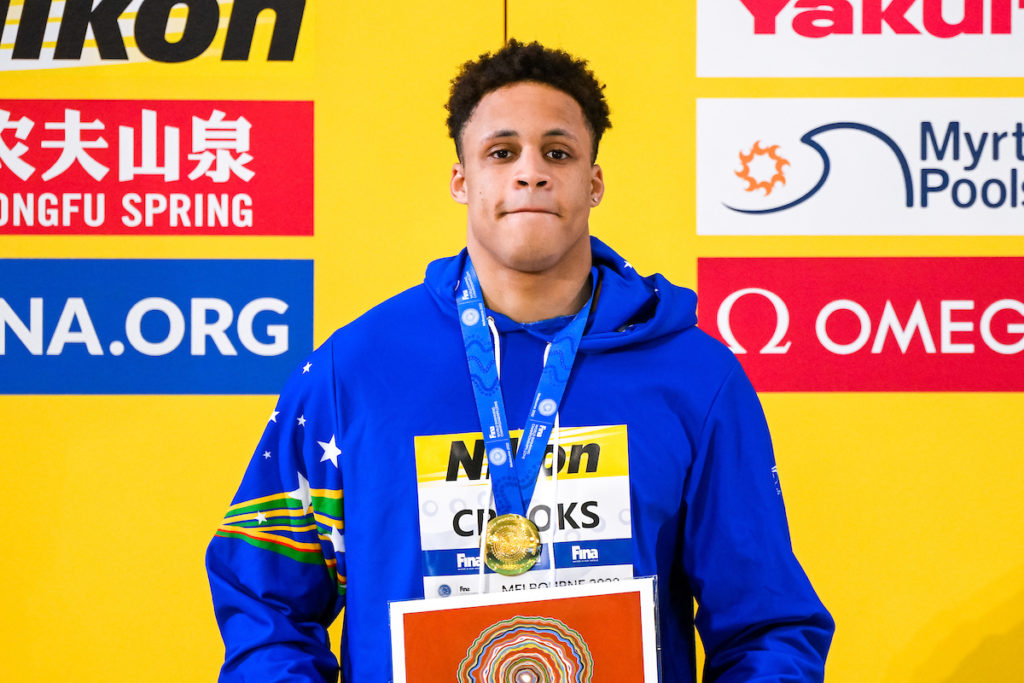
[0,0,1024,683]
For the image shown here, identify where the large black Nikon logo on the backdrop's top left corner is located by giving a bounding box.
[0,0,305,70]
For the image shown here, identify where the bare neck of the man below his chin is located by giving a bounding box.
[469,241,592,323]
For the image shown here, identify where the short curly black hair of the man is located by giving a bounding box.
[444,39,611,161]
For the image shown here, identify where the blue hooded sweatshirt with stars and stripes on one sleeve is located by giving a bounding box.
[207,238,835,683]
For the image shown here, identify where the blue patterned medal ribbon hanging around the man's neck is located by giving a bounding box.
[456,256,597,517]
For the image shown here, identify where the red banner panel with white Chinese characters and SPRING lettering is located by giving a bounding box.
[0,100,313,236]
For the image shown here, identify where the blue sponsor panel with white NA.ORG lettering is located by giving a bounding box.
[0,259,312,393]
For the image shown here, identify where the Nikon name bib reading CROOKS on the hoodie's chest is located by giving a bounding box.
[415,425,633,598]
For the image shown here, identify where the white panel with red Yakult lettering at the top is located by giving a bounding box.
[697,0,1024,77]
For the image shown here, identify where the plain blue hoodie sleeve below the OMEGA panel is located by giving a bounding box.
[683,365,835,683]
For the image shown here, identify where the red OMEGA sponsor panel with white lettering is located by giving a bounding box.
[698,257,1024,391]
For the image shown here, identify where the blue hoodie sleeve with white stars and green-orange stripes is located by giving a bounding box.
[206,343,345,682]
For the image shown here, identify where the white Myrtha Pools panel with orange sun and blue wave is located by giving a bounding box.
[697,99,1024,234]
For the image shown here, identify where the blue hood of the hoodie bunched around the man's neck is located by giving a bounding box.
[424,236,697,351]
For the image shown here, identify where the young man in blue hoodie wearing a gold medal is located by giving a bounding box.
[207,41,834,682]
